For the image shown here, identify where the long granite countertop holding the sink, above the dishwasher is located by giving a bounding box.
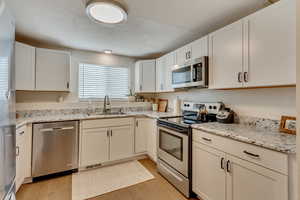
[16,111,177,128]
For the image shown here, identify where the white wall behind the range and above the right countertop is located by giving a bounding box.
[159,87,296,120]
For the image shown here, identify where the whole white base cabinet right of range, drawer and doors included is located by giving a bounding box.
[192,130,292,200]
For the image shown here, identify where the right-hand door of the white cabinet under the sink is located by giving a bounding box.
[110,126,134,161]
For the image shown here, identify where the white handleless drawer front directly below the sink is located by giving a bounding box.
[81,118,133,129]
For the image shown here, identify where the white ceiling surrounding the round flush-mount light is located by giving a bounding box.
[7,0,266,57]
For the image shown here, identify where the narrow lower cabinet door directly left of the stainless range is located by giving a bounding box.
[147,119,157,162]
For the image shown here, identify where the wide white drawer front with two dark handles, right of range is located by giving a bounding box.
[193,129,288,175]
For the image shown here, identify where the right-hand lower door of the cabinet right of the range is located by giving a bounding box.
[227,156,288,200]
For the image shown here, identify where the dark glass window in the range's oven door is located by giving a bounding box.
[159,130,183,161]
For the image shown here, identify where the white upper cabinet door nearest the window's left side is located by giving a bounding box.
[36,48,70,91]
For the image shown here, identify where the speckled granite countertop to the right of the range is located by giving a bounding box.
[192,122,296,154]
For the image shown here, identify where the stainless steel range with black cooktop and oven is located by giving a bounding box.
[157,102,223,197]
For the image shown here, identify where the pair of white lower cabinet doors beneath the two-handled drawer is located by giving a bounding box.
[193,141,288,200]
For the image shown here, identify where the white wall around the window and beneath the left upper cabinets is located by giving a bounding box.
[17,51,136,103]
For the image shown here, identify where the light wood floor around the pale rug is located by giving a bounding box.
[17,159,195,200]
